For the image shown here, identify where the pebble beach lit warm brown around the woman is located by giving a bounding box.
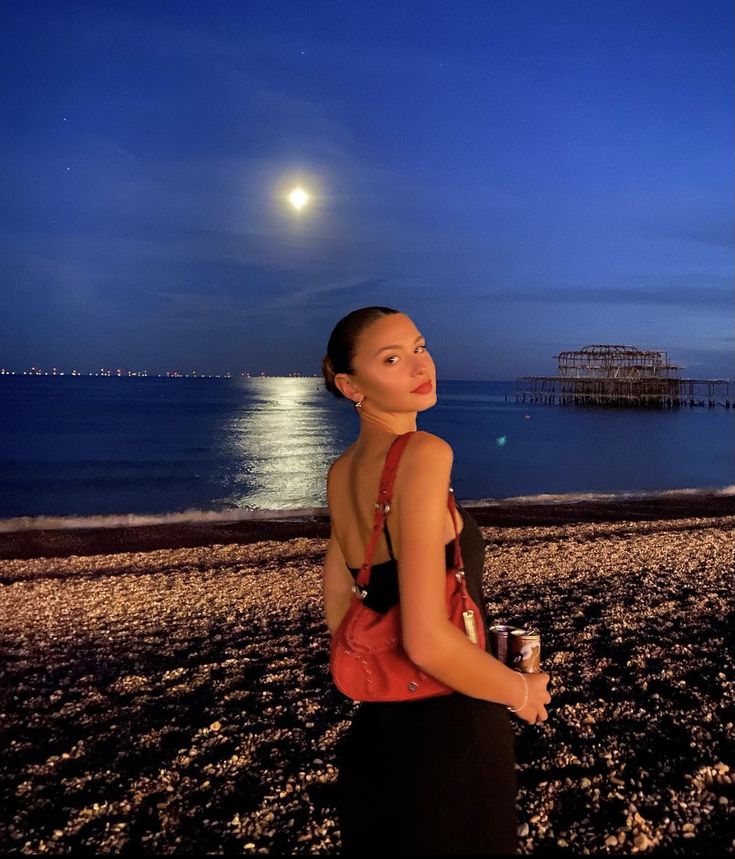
[0,496,735,855]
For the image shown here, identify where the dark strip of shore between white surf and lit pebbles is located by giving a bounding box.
[0,487,735,562]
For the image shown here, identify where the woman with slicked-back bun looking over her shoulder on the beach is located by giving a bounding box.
[322,307,551,855]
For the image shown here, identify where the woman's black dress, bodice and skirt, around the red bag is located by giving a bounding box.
[336,504,518,856]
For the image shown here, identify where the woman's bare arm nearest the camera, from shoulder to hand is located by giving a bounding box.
[396,432,550,721]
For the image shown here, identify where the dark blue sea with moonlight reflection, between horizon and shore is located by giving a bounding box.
[0,374,735,530]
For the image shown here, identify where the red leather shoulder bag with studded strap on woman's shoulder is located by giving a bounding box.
[329,430,485,701]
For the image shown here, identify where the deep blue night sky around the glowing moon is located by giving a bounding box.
[0,0,735,379]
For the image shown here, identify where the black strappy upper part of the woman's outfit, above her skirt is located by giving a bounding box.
[348,499,490,651]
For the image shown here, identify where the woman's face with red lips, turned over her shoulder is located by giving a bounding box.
[347,313,436,412]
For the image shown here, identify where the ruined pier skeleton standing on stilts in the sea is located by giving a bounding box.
[516,345,735,409]
